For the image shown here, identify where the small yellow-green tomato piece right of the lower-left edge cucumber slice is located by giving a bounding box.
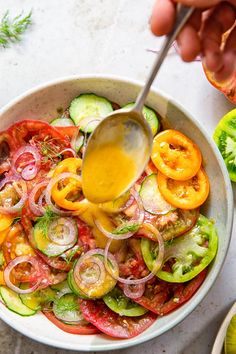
[19,286,56,311]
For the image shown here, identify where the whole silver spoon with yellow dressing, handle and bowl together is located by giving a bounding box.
[82,5,194,203]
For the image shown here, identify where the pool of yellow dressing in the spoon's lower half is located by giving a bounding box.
[82,143,137,203]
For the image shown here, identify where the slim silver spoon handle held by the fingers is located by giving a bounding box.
[133,4,194,112]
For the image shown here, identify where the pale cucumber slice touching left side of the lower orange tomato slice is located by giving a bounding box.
[139,173,175,215]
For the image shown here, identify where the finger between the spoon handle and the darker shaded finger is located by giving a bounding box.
[177,11,202,62]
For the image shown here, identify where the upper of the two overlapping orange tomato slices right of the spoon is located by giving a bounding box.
[151,129,202,181]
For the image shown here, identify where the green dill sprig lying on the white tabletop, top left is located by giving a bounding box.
[0,11,32,48]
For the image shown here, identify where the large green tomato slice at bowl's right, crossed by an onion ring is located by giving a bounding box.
[141,215,218,283]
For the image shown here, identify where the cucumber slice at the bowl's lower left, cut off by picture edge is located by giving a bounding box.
[0,286,37,317]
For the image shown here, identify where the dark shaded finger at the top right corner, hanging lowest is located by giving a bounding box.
[201,2,235,72]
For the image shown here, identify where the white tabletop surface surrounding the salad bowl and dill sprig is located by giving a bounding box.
[0,0,236,354]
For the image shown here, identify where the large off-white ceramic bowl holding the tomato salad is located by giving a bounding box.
[0,75,233,351]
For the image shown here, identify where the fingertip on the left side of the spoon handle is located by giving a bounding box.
[150,0,175,36]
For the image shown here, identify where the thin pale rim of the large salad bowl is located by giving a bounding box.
[0,73,234,351]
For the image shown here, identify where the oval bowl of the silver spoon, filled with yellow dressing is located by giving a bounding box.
[82,110,153,203]
